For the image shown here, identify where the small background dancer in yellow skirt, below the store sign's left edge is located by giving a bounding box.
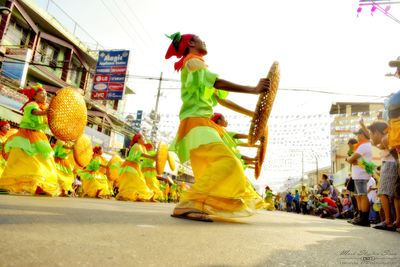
[78,145,111,198]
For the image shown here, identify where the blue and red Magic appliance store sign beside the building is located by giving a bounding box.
[92,50,129,100]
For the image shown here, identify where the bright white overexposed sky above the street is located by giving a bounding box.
[36,0,400,192]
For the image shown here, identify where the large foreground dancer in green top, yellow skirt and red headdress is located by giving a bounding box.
[165,33,269,221]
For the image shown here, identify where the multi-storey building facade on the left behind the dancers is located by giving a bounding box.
[0,0,135,154]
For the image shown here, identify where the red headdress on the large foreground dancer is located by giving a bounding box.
[165,32,195,71]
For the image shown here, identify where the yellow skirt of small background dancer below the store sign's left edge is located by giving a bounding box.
[81,172,110,197]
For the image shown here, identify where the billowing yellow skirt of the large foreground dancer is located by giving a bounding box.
[175,143,264,217]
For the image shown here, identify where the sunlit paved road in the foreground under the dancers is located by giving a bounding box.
[0,195,400,266]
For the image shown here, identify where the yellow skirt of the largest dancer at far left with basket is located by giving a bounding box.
[0,148,59,196]
